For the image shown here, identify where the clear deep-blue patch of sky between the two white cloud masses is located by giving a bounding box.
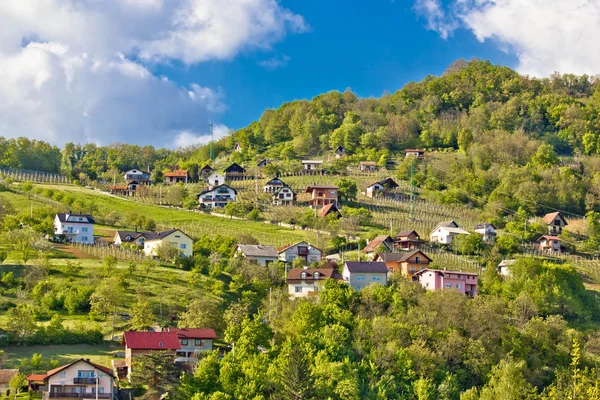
[157,0,518,129]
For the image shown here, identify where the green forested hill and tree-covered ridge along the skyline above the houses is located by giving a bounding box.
[0,60,600,213]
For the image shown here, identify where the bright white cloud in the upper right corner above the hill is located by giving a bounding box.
[415,0,600,76]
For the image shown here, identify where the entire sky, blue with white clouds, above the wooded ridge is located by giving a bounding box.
[0,0,600,148]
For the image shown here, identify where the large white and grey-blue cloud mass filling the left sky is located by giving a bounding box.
[0,0,307,145]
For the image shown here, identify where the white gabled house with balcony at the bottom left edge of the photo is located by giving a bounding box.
[27,358,116,400]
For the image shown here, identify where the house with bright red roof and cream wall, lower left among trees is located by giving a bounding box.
[120,331,181,377]
